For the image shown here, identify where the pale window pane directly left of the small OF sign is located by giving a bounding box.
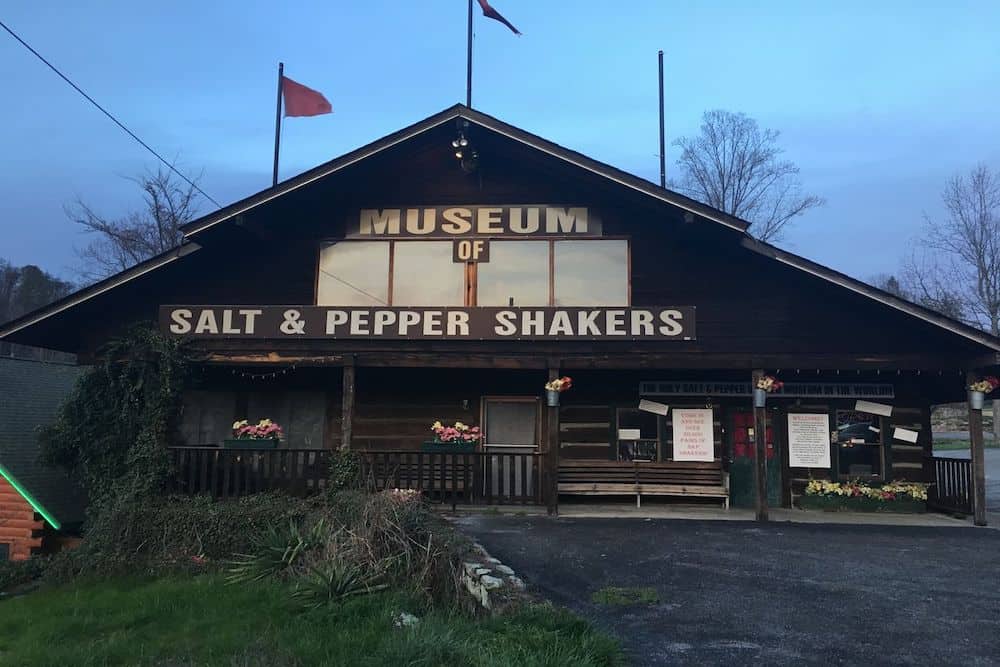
[392,241,465,306]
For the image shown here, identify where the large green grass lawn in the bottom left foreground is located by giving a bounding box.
[0,575,621,667]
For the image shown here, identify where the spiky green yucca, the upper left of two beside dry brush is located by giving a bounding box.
[226,519,329,584]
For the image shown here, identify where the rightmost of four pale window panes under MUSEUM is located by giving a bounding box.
[555,241,628,306]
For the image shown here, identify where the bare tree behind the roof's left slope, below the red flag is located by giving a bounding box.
[66,169,197,281]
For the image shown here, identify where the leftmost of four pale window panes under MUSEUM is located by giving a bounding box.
[316,241,389,306]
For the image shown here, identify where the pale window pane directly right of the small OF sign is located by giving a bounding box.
[477,241,549,306]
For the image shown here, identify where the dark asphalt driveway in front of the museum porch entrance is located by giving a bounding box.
[457,515,1000,665]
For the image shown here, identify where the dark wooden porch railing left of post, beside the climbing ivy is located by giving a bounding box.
[168,447,330,498]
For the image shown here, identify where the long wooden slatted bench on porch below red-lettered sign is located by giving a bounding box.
[559,460,729,509]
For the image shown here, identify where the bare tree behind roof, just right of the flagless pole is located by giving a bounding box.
[674,110,824,241]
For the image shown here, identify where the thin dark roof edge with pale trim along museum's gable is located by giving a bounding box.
[0,104,1000,353]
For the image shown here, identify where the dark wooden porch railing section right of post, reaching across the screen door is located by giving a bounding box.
[358,450,544,506]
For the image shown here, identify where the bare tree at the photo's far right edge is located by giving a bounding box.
[905,164,1000,439]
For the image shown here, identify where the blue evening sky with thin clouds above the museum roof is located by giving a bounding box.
[0,0,1000,278]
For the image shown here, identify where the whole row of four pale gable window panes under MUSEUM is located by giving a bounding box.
[316,239,631,307]
